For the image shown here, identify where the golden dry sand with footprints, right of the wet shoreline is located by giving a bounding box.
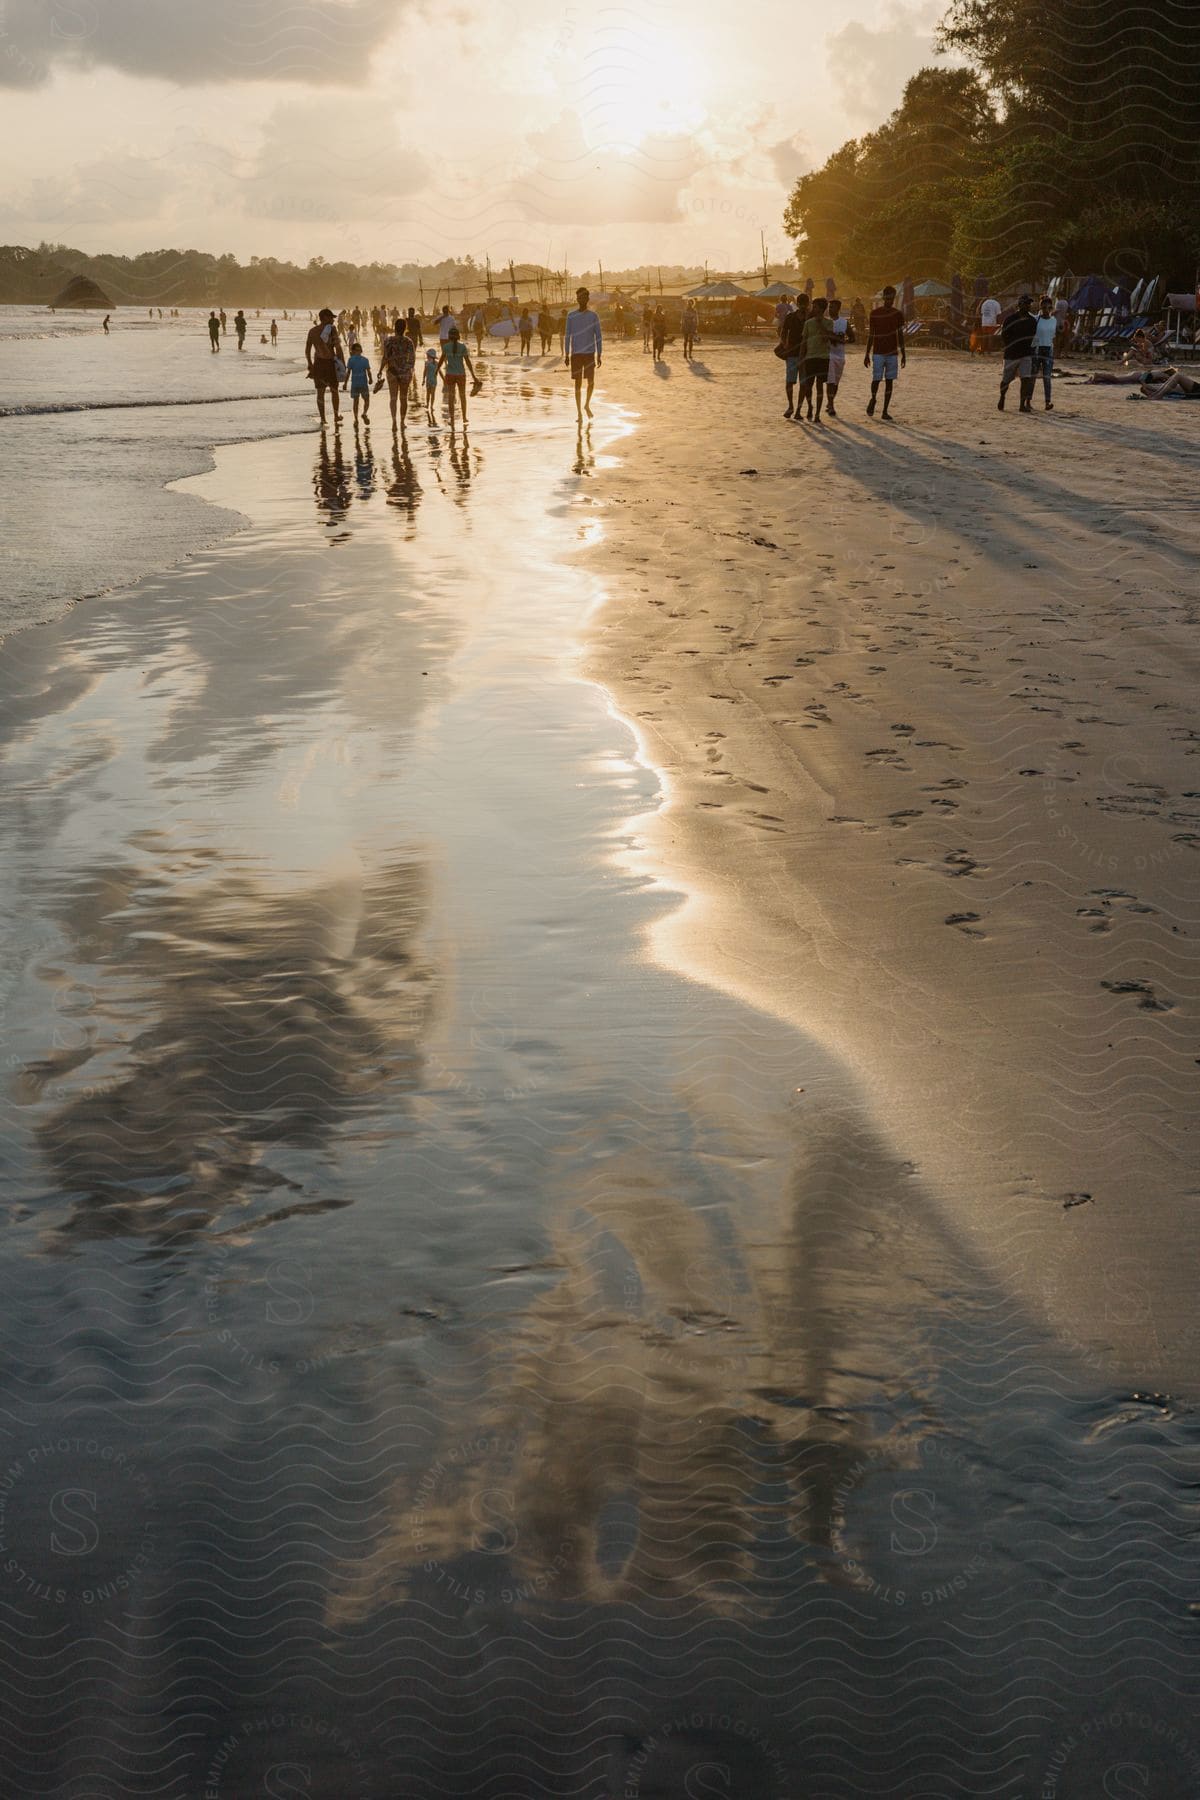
[588,344,1200,1386]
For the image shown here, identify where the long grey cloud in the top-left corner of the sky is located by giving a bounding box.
[0,0,398,88]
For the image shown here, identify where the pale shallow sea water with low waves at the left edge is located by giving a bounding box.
[0,306,313,635]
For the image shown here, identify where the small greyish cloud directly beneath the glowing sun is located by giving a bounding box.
[513,112,711,225]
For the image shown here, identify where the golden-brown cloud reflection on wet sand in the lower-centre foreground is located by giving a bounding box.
[329,1114,968,1627]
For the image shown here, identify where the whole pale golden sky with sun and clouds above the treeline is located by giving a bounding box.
[0,0,941,270]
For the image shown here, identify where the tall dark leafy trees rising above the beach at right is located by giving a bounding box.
[784,0,1200,288]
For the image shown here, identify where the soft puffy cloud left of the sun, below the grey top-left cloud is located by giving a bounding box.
[234,94,430,225]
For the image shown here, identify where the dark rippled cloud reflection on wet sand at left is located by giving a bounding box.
[18,848,430,1240]
